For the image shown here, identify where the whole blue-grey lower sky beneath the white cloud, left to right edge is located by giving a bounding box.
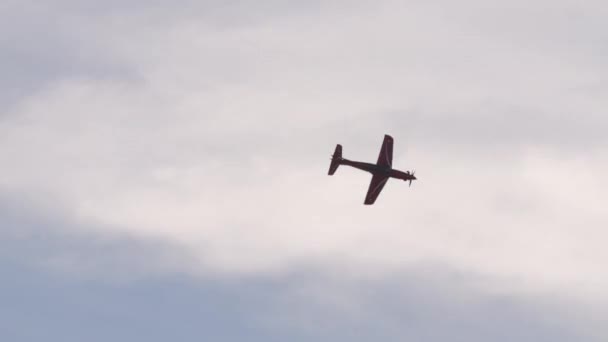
[0,196,605,342]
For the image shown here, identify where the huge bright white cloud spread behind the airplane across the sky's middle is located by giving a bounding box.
[0,2,608,326]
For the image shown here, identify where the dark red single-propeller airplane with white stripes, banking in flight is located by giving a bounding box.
[328,134,416,205]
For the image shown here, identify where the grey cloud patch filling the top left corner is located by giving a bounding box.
[0,1,136,108]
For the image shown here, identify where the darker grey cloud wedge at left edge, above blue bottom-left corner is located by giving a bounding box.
[0,189,193,281]
